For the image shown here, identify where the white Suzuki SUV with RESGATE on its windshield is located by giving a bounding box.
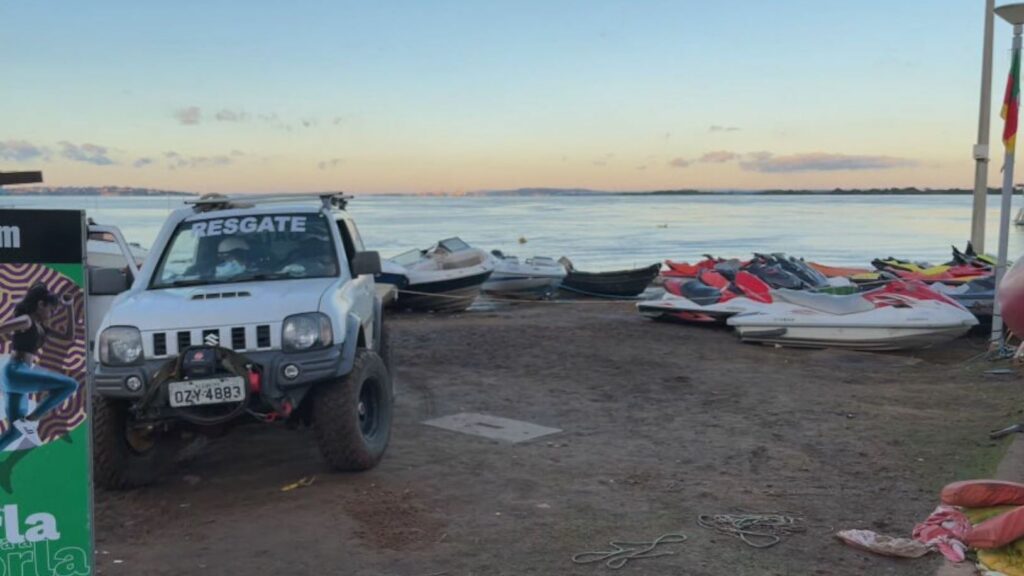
[90,195,394,488]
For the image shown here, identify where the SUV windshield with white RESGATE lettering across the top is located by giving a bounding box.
[150,214,338,288]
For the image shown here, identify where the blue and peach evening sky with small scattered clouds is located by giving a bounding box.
[0,0,1012,194]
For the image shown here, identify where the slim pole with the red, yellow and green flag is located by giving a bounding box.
[990,10,1024,344]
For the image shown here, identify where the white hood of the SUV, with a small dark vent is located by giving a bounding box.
[103,278,338,332]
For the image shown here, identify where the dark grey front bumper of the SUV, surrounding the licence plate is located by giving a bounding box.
[92,343,355,420]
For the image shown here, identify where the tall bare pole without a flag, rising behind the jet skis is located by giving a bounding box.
[971,0,995,254]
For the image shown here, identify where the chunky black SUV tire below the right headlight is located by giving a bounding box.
[312,348,393,470]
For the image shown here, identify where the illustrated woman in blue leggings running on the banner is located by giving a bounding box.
[0,283,78,451]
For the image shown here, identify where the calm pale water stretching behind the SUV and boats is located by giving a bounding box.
[8,196,1024,269]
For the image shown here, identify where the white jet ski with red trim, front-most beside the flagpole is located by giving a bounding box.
[726,281,978,351]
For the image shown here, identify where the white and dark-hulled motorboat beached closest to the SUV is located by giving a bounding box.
[377,238,495,312]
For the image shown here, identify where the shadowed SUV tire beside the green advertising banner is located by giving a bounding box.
[92,396,173,490]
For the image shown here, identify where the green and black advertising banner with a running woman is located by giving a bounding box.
[0,209,93,576]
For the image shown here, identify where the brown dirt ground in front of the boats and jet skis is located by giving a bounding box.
[96,302,1024,576]
